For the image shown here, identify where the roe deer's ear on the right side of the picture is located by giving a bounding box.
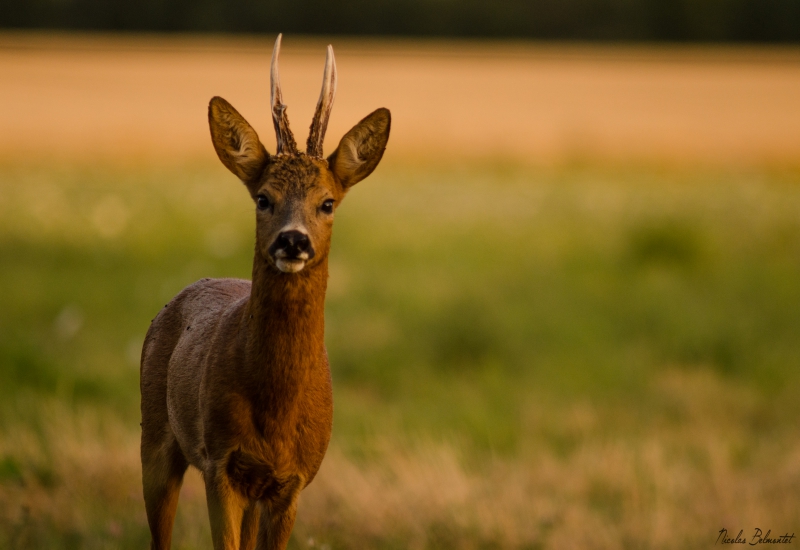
[328,108,392,190]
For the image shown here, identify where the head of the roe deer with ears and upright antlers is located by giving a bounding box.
[208,35,391,273]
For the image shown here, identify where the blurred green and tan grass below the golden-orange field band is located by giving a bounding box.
[0,154,800,549]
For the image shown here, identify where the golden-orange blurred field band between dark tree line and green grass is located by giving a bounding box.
[0,34,800,163]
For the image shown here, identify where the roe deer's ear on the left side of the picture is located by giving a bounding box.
[208,97,269,191]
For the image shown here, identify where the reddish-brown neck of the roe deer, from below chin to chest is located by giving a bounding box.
[244,252,328,420]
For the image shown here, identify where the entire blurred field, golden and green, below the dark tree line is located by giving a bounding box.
[0,34,800,549]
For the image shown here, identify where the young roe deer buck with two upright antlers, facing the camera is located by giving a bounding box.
[141,35,391,550]
